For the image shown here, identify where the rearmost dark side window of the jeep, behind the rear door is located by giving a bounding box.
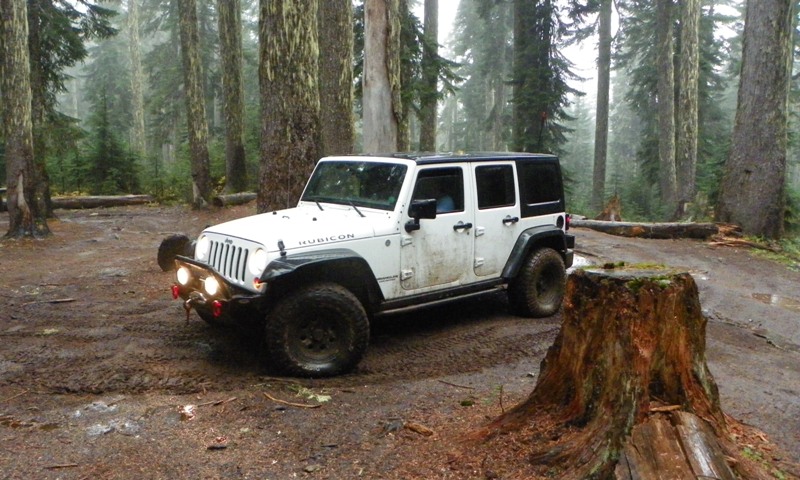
[517,162,565,217]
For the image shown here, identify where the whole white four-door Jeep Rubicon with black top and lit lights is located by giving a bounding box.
[166,153,575,376]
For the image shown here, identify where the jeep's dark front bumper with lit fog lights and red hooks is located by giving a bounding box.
[172,256,266,324]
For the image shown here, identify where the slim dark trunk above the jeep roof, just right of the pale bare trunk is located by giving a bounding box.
[419,0,439,152]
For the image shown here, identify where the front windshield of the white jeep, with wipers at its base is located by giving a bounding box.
[301,161,406,210]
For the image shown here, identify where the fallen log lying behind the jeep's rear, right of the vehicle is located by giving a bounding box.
[570,220,719,240]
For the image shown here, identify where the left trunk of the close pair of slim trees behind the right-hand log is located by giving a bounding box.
[656,0,678,213]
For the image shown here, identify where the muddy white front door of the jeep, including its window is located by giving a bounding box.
[400,165,474,293]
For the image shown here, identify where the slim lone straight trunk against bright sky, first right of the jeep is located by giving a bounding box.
[592,0,612,210]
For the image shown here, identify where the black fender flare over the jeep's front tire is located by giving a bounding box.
[260,248,383,312]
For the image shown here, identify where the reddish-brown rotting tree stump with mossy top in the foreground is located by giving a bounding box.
[479,268,760,479]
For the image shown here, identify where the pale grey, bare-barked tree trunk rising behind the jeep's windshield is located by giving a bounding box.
[362,0,403,153]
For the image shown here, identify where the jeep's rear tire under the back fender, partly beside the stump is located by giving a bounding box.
[508,248,567,318]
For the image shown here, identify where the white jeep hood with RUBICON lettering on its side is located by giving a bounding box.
[204,204,391,251]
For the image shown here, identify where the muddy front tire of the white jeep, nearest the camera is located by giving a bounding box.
[264,283,369,377]
